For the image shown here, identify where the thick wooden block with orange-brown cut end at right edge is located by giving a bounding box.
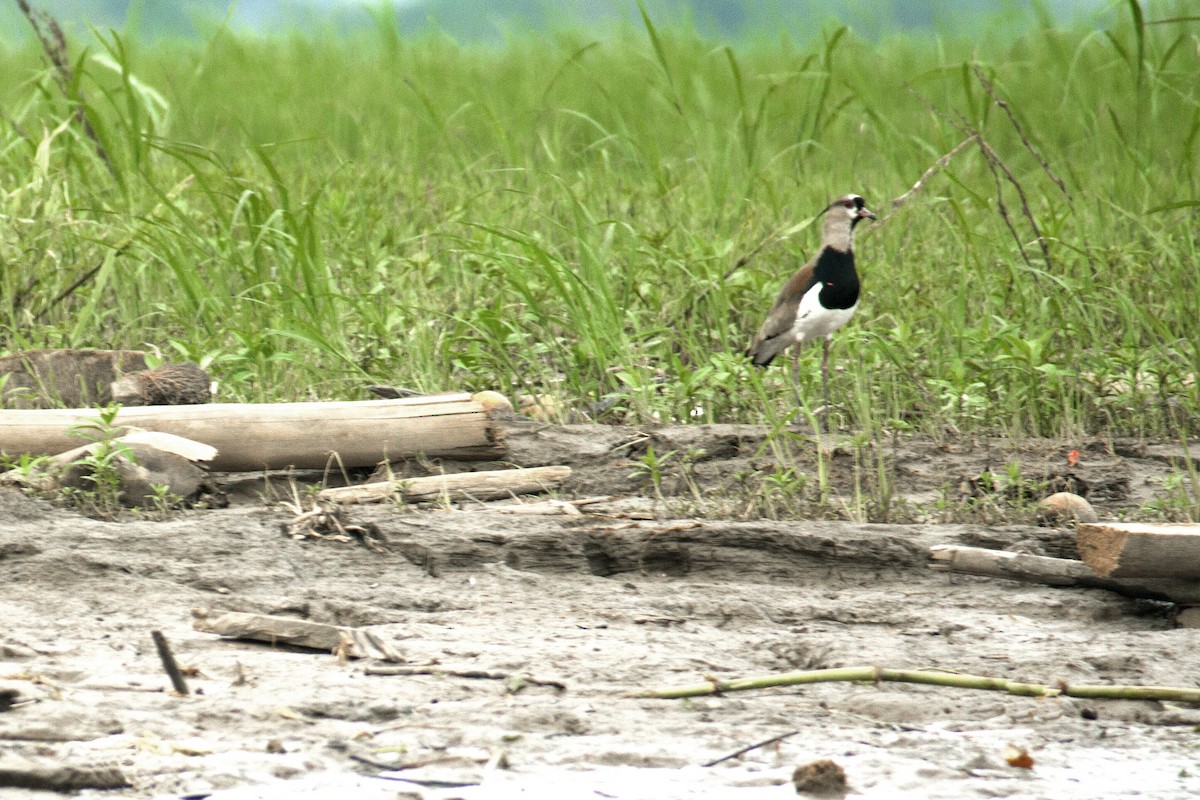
[1075,522,1200,579]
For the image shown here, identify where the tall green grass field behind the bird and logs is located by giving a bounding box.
[0,2,1200,437]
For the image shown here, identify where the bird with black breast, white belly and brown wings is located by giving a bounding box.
[746,194,877,424]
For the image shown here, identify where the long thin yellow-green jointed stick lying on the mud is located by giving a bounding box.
[626,667,1200,703]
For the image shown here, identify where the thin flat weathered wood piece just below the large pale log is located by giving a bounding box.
[317,467,571,504]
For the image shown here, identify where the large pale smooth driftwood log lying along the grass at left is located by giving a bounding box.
[0,393,505,471]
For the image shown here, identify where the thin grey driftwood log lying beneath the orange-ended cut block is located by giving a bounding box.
[930,545,1200,604]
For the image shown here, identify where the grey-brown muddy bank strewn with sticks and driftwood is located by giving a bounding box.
[0,426,1200,800]
